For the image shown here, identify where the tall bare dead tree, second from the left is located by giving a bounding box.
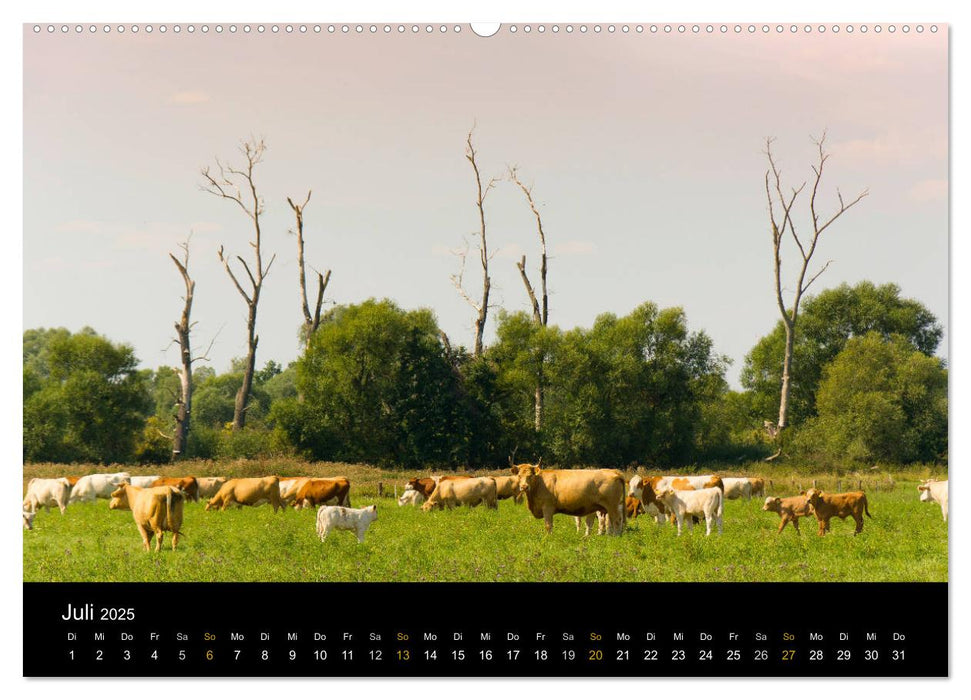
[201,139,276,431]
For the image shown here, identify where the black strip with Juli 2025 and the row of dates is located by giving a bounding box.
[24,583,948,677]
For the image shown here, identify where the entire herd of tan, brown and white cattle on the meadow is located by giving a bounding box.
[23,463,948,551]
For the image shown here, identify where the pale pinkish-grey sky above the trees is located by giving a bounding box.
[24,25,948,385]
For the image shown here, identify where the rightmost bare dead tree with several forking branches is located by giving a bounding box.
[765,131,870,460]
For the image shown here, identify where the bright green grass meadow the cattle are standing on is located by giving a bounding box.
[23,465,948,581]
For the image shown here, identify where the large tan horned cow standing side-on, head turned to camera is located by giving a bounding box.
[512,464,626,535]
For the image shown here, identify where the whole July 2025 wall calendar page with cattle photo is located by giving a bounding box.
[22,22,950,678]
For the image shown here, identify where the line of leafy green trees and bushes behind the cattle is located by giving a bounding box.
[23,282,948,468]
